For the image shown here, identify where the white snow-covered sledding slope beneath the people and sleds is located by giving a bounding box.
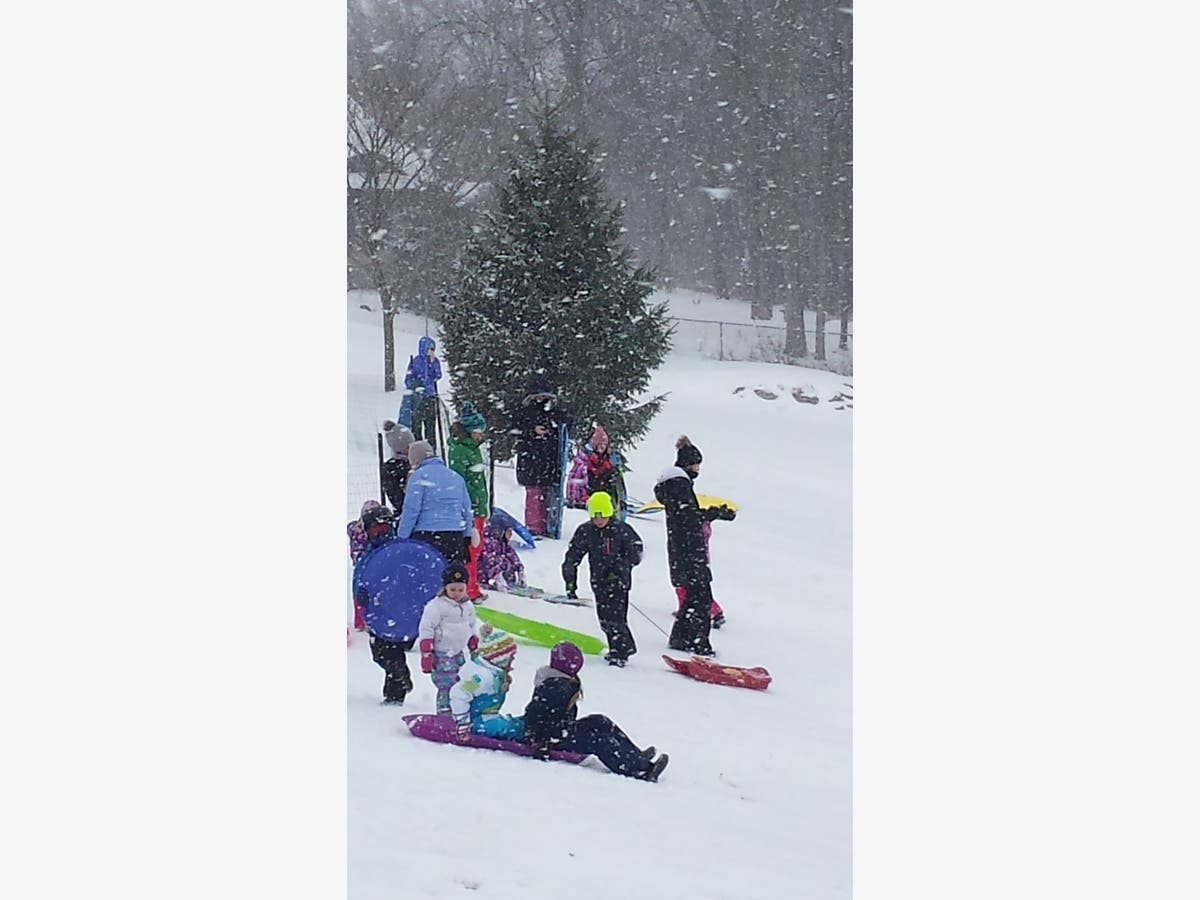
[347,292,853,900]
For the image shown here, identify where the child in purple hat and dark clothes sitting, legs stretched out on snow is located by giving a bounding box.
[524,641,668,781]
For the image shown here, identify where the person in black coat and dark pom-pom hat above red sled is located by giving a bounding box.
[654,434,736,656]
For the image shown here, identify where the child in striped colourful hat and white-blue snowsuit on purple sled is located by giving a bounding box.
[450,622,524,740]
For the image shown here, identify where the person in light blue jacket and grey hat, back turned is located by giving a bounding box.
[396,440,480,564]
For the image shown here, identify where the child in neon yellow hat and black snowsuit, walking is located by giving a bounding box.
[563,491,642,667]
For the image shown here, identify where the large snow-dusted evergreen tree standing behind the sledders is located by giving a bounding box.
[440,118,672,460]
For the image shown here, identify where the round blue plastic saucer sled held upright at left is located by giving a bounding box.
[354,538,446,641]
